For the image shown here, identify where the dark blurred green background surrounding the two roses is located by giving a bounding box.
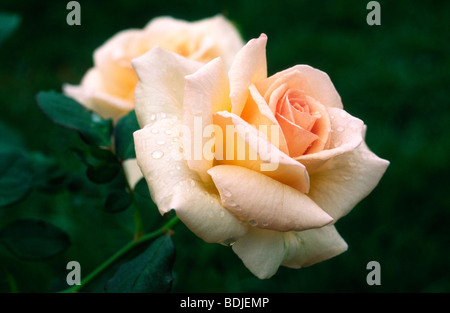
[0,0,450,292]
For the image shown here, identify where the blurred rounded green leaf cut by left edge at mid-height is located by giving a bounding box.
[0,150,33,207]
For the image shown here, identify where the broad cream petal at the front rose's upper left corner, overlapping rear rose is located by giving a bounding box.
[132,47,202,127]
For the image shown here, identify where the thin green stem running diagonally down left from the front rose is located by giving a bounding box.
[61,216,179,293]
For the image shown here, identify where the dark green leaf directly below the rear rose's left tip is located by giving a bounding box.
[37,91,112,146]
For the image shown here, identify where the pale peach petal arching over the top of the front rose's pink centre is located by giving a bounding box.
[256,65,343,109]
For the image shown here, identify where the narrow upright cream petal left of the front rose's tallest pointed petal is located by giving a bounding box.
[183,58,231,181]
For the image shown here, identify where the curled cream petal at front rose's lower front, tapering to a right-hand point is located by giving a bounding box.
[208,165,333,232]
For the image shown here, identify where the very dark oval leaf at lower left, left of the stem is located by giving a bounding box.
[0,219,70,261]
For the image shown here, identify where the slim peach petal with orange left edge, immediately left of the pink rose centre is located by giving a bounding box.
[241,84,289,155]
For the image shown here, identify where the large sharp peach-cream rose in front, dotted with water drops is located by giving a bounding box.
[133,35,389,278]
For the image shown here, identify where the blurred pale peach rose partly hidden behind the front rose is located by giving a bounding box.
[63,15,243,186]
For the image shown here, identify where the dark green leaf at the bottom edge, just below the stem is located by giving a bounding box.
[105,235,175,293]
